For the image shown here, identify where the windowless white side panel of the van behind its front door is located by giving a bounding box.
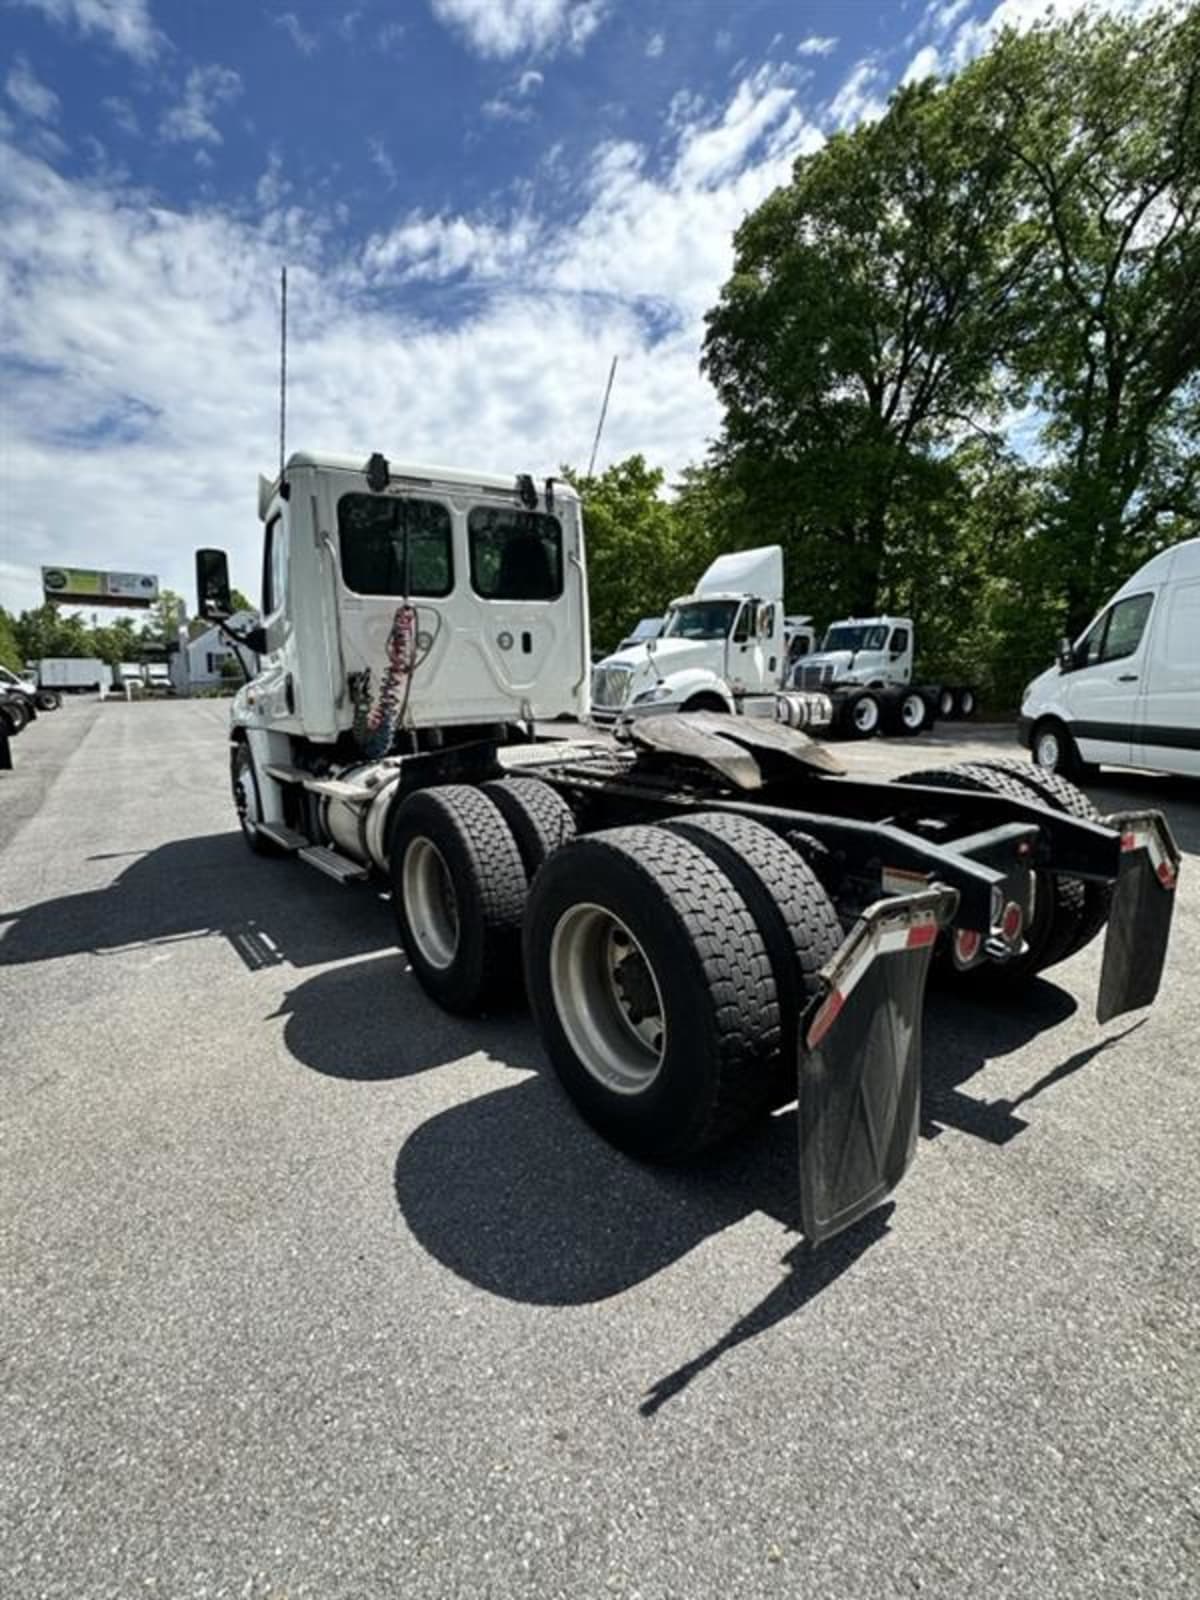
[1134,574,1200,778]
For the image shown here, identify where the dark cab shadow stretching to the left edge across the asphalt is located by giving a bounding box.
[0,832,395,971]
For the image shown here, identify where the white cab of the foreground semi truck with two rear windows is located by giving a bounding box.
[210,451,587,754]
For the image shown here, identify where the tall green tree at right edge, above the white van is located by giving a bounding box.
[979,8,1200,627]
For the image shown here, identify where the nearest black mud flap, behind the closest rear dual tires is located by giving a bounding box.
[798,885,958,1245]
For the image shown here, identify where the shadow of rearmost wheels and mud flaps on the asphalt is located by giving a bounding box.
[387,974,1139,1416]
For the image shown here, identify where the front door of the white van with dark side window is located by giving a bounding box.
[1062,592,1154,766]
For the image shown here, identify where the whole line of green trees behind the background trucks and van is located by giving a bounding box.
[576,8,1200,706]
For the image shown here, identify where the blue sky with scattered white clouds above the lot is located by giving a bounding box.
[0,0,1120,610]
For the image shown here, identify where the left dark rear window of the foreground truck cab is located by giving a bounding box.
[338,494,454,597]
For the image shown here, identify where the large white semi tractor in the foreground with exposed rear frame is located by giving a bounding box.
[197,453,1179,1243]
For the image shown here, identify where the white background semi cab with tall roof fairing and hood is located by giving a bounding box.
[592,544,786,722]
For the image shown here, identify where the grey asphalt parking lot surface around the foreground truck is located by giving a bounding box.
[0,701,1200,1600]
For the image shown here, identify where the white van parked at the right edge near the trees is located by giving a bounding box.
[1018,539,1200,778]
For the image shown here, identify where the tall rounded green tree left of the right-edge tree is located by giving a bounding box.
[704,83,1035,614]
